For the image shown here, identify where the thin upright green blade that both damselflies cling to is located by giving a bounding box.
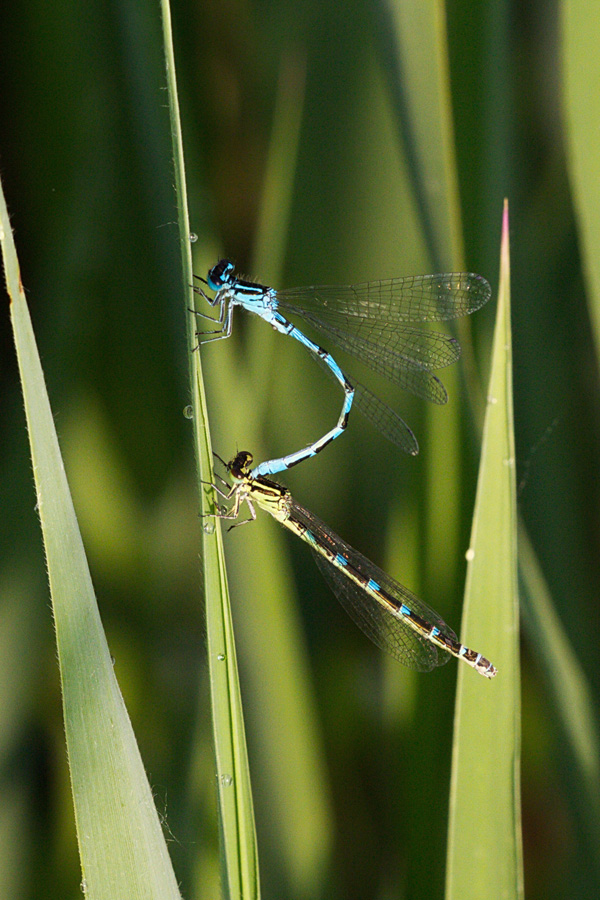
[162,0,260,900]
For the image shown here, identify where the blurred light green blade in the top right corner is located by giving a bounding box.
[561,0,600,359]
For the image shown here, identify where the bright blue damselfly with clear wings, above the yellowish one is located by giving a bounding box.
[195,259,491,477]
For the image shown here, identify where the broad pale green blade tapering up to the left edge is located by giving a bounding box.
[0,172,180,900]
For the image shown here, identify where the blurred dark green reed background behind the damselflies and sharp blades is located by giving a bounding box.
[0,0,600,900]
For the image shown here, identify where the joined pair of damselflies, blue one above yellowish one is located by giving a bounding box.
[195,259,497,678]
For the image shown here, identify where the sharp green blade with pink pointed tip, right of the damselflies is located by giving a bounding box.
[446,206,523,900]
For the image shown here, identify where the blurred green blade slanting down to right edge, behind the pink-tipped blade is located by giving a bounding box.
[519,525,600,863]
